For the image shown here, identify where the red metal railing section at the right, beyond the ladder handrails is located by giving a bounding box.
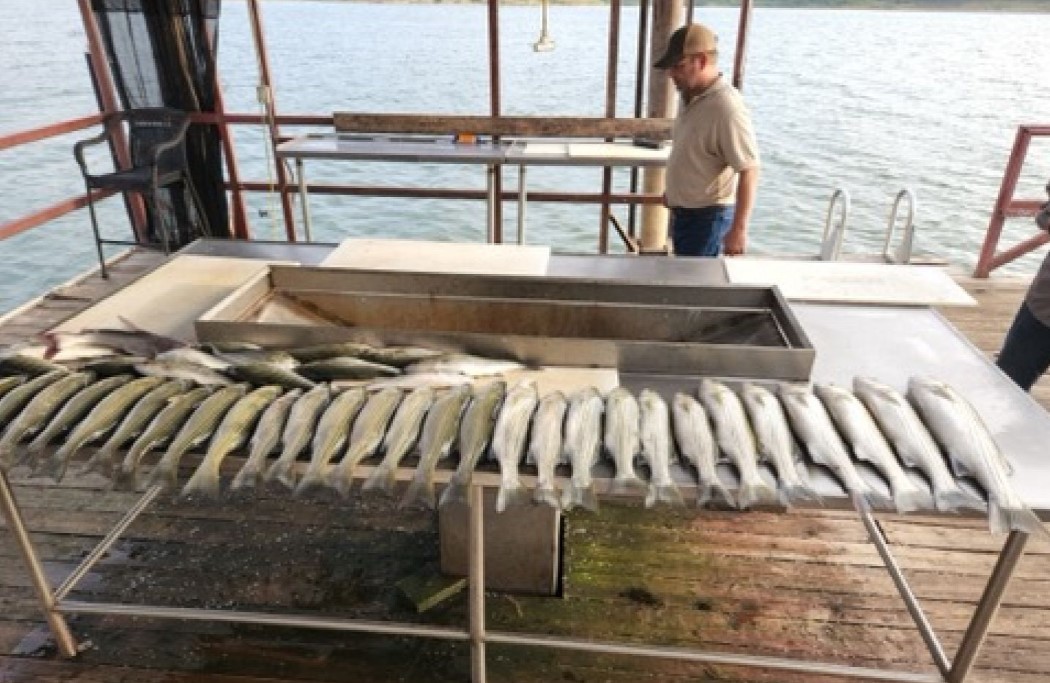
[973,125,1050,277]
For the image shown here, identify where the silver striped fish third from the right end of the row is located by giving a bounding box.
[816,385,932,515]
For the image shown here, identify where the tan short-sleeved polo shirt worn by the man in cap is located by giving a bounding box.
[667,76,759,209]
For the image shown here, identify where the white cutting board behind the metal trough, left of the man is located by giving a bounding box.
[321,237,550,275]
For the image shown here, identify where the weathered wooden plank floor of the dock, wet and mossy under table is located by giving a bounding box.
[0,252,1050,683]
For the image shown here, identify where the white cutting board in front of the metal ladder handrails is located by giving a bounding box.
[725,258,977,306]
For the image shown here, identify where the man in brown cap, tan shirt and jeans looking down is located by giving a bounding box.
[654,24,759,256]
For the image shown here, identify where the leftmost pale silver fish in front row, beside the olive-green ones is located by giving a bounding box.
[492,382,540,512]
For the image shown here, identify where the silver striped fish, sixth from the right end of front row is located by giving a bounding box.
[700,379,777,509]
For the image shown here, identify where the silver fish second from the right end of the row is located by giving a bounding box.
[854,377,985,512]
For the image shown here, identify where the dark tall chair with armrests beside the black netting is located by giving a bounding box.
[74,107,207,277]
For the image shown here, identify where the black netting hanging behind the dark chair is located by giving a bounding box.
[91,0,229,246]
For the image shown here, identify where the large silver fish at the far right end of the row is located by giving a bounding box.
[908,377,1050,538]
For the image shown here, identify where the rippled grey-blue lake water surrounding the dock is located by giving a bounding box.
[0,0,1050,310]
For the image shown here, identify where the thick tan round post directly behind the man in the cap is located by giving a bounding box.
[638,2,683,251]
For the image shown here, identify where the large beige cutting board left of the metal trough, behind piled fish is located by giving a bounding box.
[55,254,295,342]
